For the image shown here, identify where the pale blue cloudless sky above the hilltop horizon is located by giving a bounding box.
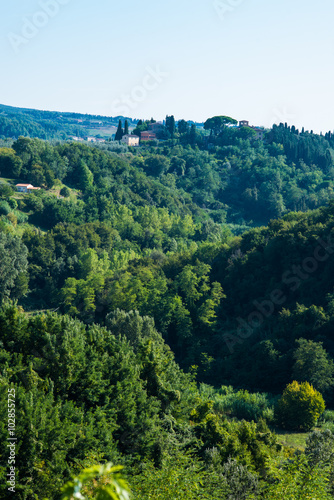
[0,0,334,133]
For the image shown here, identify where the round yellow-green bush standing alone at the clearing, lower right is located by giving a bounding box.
[275,381,325,431]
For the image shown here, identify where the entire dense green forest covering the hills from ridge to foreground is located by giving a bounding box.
[0,112,334,500]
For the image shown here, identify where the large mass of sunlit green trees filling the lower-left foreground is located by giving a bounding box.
[0,302,282,500]
